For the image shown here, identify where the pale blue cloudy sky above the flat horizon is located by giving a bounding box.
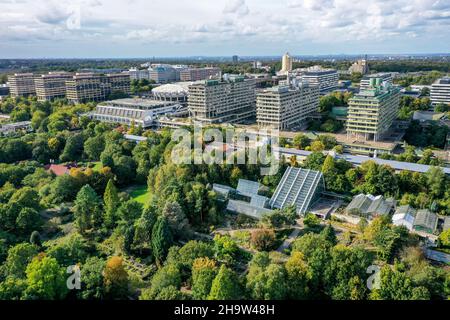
[0,0,450,58]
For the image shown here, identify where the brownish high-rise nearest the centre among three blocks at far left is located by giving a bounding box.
[66,73,131,103]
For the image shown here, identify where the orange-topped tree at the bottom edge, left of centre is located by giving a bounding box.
[103,256,128,299]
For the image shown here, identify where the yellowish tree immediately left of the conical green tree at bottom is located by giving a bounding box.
[192,257,217,300]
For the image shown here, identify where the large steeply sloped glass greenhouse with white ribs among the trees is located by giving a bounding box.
[269,167,325,215]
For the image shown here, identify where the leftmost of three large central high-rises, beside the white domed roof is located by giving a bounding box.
[188,75,256,124]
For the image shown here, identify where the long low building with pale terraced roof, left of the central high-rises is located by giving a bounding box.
[88,98,186,128]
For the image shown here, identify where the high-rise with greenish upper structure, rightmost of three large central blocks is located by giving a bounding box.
[347,78,400,141]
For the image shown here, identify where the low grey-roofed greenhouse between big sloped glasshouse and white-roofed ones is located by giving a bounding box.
[345,194,395,219]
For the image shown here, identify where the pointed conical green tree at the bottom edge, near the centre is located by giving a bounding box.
[208,265,241,300]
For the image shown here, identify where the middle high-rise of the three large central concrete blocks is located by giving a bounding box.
[256,84,320,130]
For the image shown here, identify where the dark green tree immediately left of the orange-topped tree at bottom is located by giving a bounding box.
[78,257,106,300]
